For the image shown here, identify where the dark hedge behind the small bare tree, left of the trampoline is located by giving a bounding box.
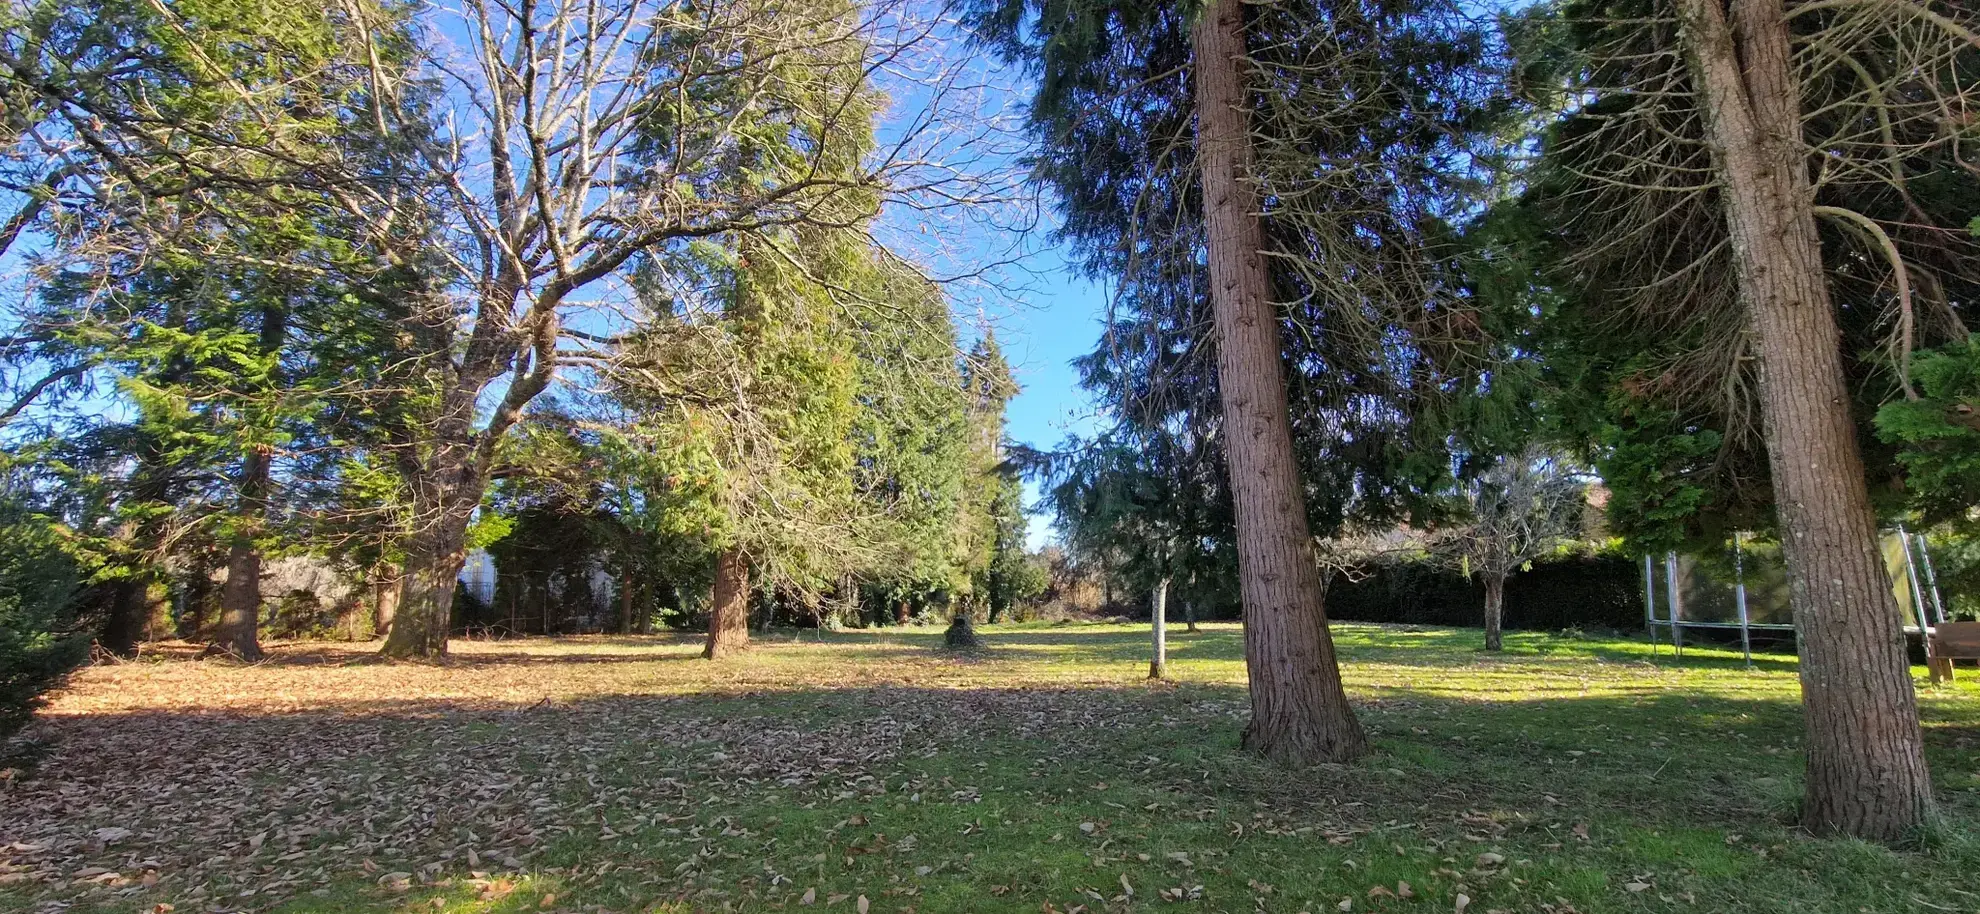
[1327,554,1643,631]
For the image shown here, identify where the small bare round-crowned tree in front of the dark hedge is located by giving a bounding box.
[1432,449,1588,651]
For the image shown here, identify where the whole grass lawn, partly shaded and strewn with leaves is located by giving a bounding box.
[0,625,1980,914]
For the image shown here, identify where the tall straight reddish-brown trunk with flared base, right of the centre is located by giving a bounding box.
[1194,0,1368,764]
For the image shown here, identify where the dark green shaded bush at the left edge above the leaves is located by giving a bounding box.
[0,503,89,736]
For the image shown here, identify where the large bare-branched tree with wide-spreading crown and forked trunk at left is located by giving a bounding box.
[0,0,1000,657]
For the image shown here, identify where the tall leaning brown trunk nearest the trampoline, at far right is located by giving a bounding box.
[1681,0,1932,841]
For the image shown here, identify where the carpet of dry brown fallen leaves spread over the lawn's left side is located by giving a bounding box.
[0,639,1956,914]
